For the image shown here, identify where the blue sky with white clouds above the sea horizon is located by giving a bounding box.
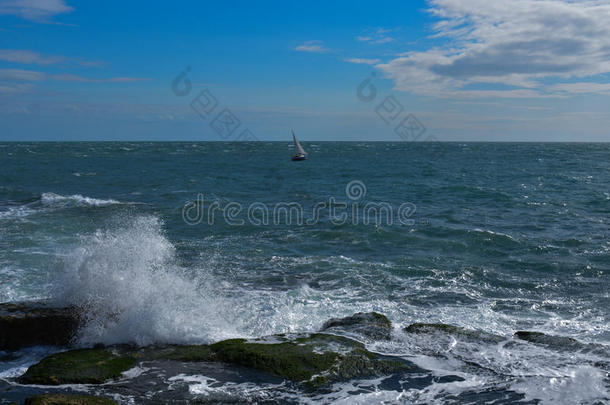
[0,0,610,142]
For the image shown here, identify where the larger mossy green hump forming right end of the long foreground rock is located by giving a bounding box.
[210,333,412,388]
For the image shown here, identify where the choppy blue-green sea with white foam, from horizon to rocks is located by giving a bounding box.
[0,142,610,404]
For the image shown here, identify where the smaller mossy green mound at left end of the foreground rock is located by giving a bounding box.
[19,348,136,385]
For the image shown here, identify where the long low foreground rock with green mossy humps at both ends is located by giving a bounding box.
[19,333,408,388]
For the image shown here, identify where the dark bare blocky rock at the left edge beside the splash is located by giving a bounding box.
[0,302,79,350]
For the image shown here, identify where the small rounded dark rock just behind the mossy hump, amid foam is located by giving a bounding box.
[321,312,392,340]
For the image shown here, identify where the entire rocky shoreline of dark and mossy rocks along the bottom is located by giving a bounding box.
[0,302,606,405]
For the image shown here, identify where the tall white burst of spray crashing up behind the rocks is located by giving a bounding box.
[53,216,235,345]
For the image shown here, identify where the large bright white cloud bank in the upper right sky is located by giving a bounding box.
[377,0,610,97]
